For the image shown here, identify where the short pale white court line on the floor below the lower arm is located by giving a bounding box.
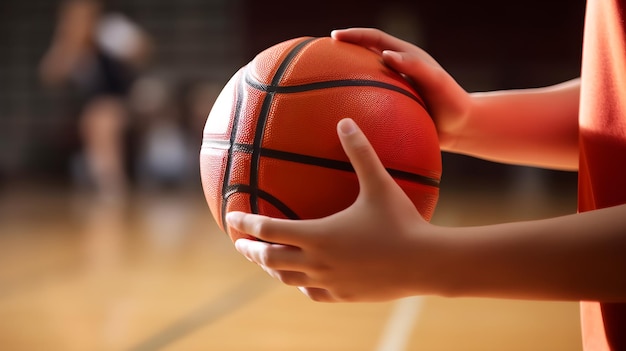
[375,296,424,351]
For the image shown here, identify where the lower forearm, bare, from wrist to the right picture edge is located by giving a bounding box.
[428,205,626,301]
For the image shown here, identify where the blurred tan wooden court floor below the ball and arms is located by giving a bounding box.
[0,174,581,351]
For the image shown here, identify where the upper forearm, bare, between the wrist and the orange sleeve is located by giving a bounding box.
[442,79,580,170]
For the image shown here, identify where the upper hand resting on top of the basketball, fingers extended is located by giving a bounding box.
[331,28,471,150]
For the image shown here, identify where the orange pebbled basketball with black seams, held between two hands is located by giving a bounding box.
[200,37,441,241]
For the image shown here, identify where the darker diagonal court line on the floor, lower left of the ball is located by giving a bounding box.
[130,273,276,351]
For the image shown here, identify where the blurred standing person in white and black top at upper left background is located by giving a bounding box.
[39,0,152,204]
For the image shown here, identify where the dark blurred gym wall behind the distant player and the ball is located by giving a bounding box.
[0,0,584,192]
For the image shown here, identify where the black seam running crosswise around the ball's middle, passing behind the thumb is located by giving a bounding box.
[203,140,440,187]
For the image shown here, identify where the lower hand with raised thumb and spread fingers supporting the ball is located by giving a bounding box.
[226,119,437,302]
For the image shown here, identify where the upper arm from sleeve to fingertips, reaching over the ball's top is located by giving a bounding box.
[332,28,580,170]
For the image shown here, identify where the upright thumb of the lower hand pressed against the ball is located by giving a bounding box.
[337,118,393,195]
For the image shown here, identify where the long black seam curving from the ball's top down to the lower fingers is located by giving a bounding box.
[249,38,318,213]
